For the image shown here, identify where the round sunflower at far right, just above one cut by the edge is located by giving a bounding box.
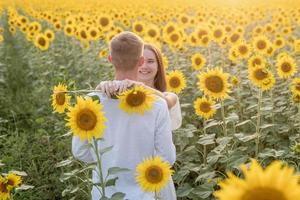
[276,56,297,79]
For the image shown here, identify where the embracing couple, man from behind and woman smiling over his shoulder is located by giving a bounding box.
[72,32,181,200]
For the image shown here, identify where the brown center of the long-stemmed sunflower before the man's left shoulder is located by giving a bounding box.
[77,109,97,131]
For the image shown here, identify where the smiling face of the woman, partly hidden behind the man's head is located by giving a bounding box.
[138,49,158,83]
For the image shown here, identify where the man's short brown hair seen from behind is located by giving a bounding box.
[109,31,144,71]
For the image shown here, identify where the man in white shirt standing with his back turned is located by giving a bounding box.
[72,32,176,200]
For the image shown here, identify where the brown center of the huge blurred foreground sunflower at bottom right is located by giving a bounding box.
[241,188,287,200]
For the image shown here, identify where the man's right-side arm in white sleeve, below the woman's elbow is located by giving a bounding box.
[154,101,176,165]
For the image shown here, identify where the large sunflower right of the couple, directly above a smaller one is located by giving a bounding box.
[198,68,229,99]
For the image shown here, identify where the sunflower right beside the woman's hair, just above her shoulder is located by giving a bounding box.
[166,70,186,94]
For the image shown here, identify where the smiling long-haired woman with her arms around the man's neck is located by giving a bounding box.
[96,44,182,200]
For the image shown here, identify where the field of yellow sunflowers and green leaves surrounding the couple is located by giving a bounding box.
[0,0,300,200]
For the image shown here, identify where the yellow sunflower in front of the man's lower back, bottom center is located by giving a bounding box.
[136,156,173,192]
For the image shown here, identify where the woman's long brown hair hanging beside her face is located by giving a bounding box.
[144,44,167,92]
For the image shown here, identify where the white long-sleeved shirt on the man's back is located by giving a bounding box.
[72,93,176,200]
